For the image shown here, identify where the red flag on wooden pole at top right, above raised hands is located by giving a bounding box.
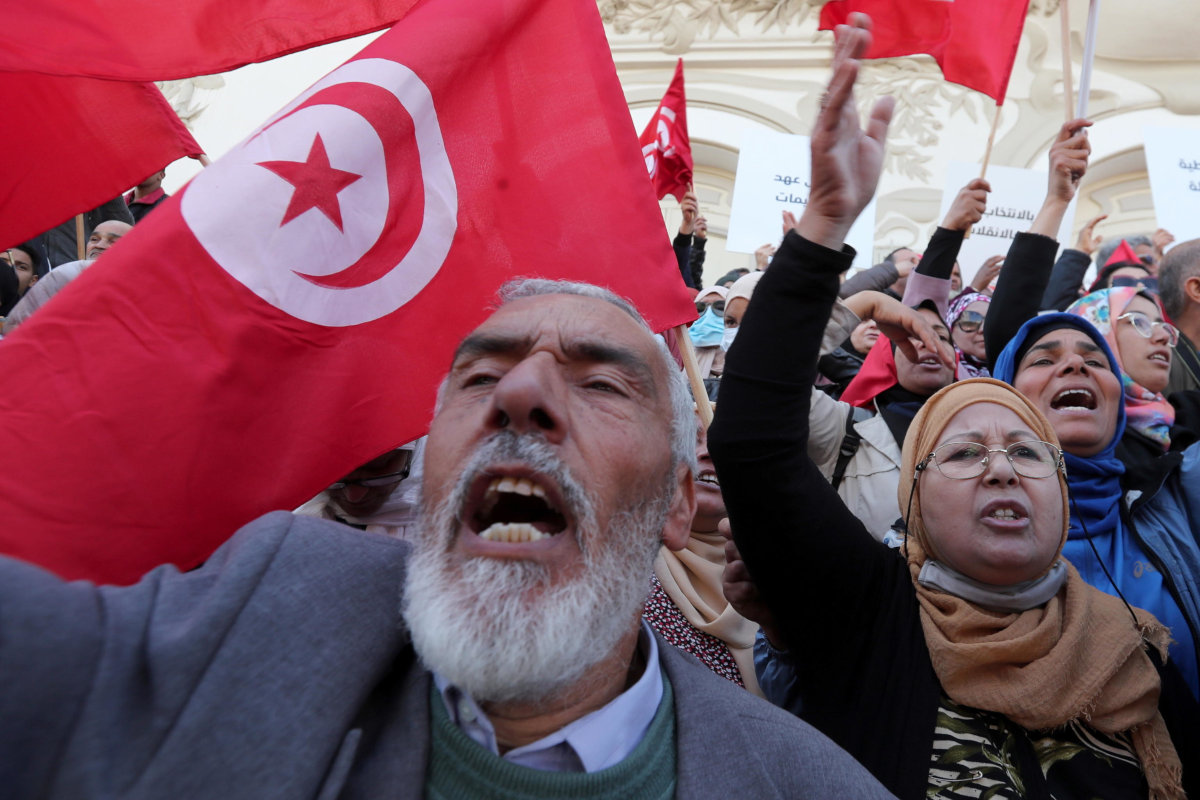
[821,0,1030,106]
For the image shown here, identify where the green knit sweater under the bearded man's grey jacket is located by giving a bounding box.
[425,675,676,800]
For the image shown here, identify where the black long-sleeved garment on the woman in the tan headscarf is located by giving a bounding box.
[708,233,1196,800]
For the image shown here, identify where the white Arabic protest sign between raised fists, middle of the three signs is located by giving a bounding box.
[937,161,1075,285]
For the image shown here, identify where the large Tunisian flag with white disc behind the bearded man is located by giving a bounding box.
[0,0,696,583]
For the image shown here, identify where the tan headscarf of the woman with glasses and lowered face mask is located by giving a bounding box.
[898,378,1184,800]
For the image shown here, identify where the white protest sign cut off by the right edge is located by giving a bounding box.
[1142,127,1200,241]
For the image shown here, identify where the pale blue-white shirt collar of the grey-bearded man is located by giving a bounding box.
[433,620,662,772]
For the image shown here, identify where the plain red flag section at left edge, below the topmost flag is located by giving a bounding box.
[0,72,203,253]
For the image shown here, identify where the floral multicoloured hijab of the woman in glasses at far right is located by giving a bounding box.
[1067,287,1175,451]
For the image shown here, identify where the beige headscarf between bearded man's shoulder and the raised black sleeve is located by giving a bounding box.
[654,530,762,697]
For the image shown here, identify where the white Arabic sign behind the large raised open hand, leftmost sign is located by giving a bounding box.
[725,131,875,267]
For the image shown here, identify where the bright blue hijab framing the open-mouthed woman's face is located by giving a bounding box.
[992,313,1126,540]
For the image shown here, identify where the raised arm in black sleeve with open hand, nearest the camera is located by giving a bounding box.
[709,15,919,652]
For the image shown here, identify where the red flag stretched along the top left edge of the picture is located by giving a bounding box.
[0,0,416,80]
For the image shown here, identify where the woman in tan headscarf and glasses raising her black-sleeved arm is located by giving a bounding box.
[709,14,1200,800]
